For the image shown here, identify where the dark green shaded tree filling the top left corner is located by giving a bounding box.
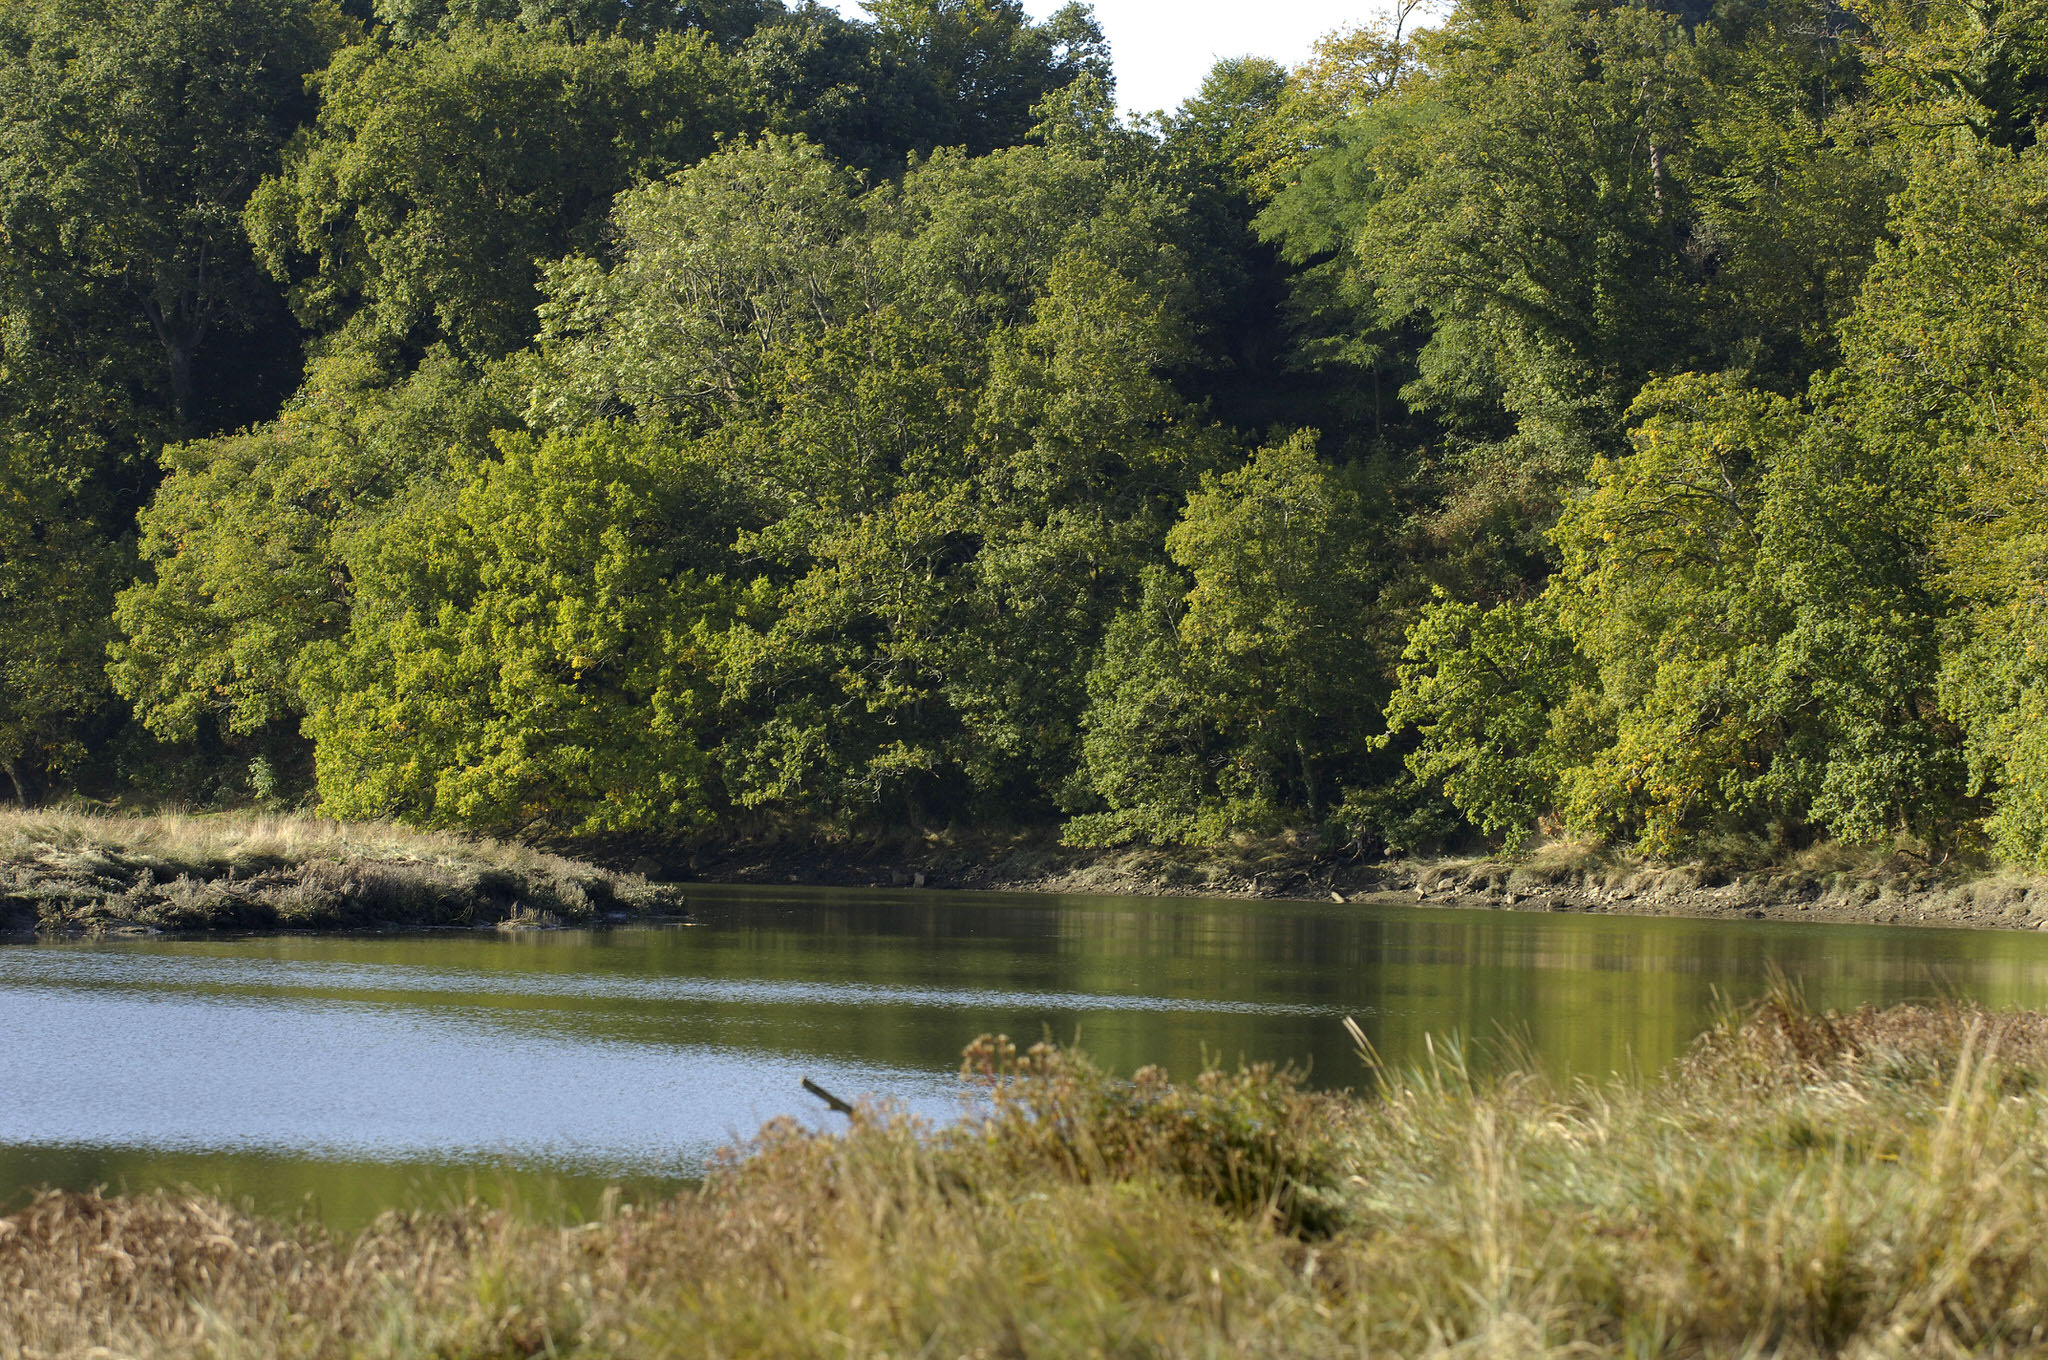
[0,0,348,432]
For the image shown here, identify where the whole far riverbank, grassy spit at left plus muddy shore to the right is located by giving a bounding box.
[0,809,2048,932]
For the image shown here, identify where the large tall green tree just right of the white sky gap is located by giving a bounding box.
[1260,2,1890,596]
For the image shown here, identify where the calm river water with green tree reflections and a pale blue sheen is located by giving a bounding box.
[12,887,2048,1227]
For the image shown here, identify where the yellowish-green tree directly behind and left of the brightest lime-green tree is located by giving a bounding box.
[109,354,516,741]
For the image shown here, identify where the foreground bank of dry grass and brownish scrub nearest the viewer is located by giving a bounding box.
[0,995,2048,1360]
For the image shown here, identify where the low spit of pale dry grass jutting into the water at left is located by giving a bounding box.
[0,809,682,932]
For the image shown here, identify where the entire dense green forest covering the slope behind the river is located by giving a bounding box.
[0,0,2048,862]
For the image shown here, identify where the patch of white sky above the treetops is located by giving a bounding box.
[834,0,1409,113]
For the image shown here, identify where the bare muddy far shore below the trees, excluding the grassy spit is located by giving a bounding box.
[679,836,2048,930]
